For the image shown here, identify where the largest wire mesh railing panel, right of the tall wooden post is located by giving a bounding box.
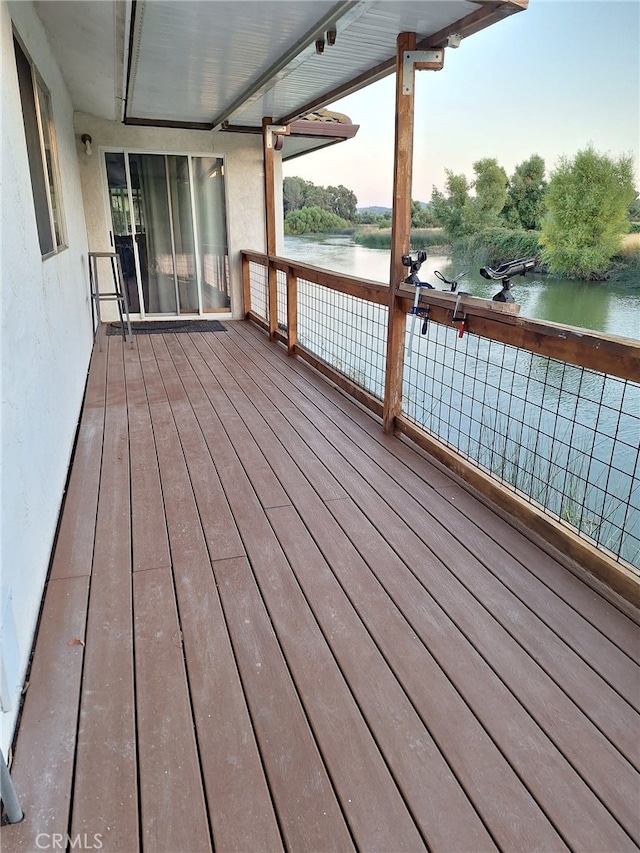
[403,321,640,571]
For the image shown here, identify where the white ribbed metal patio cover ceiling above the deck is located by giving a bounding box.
[34,0,528,153]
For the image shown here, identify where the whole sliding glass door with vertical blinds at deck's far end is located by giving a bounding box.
[105,152,231,317]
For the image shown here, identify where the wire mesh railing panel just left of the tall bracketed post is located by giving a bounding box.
[298,278,388,399]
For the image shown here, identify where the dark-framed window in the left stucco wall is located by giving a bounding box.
[13,38,65,257]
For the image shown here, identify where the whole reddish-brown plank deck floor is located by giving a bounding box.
[6,323,640,853]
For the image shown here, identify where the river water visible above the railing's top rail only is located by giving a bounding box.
[284,236,640,340]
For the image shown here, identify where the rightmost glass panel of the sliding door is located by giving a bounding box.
[193,157,231,311]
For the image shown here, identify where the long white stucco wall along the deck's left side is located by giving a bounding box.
[0,0,92,750]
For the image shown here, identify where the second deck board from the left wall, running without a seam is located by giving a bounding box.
[71,340,138,849]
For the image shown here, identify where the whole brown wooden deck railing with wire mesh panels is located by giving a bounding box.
[242,252,640,598]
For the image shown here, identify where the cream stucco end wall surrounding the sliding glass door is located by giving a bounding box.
[75,113,265,319]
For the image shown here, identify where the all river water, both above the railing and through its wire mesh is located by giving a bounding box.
[284,236,640,571]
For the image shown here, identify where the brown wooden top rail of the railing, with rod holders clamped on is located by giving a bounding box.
[242,251,640,382]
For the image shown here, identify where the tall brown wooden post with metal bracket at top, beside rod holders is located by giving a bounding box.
[382,33,416,432]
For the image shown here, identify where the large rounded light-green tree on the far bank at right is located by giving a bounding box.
[540,146,635,278]
